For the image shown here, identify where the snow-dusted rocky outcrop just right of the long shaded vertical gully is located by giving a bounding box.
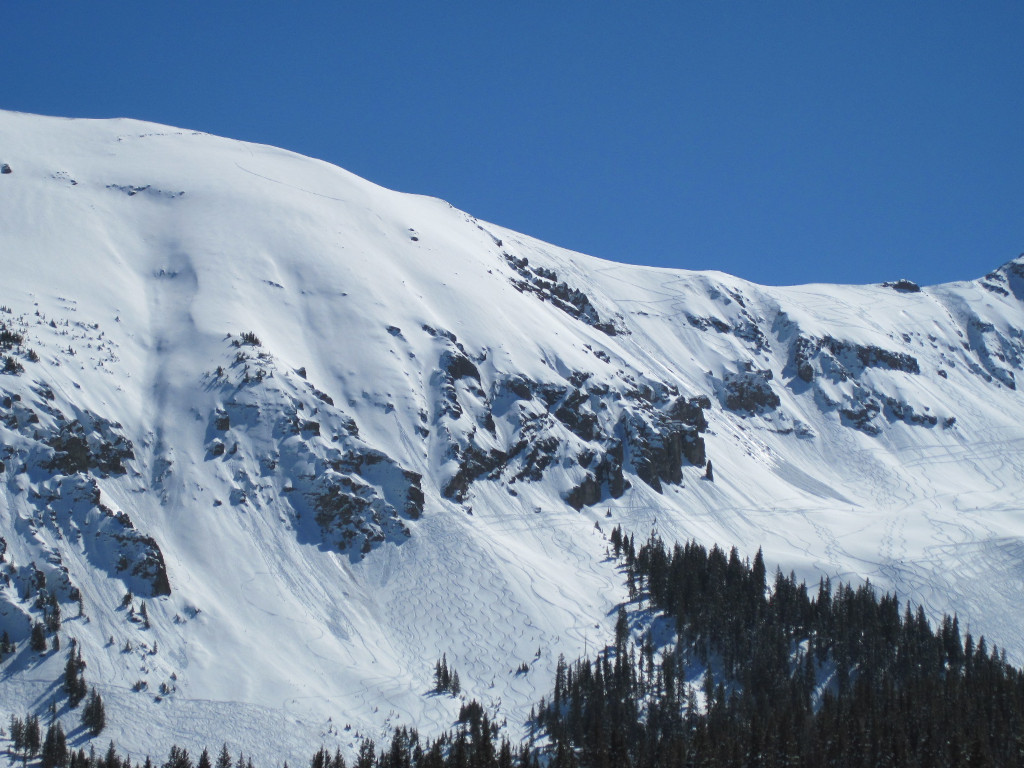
[207,342,419,557]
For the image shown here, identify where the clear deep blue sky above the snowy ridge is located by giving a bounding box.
[0,0,1024,284]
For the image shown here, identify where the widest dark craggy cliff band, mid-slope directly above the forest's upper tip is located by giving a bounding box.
[423,331,711,509]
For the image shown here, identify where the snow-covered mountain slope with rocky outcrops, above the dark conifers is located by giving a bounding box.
[0,113,1024,762]
